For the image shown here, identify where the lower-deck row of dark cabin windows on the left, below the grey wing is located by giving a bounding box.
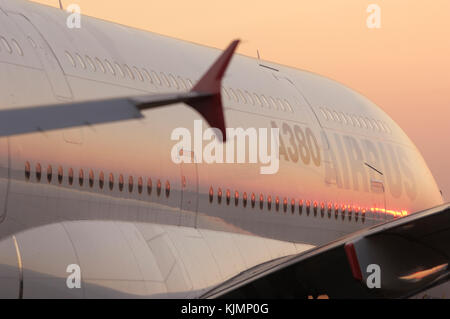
[25,162,170,197]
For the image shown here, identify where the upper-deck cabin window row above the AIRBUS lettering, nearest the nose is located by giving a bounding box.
[319,107,392,134]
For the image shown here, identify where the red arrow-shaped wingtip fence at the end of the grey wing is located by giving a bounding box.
[187,40,240,142]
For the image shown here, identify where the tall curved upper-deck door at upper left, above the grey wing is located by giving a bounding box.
[8,12,73,101]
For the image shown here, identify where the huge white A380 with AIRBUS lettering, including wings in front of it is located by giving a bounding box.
[0,0,450,298]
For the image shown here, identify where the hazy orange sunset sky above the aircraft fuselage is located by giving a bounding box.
[32,0,450,199]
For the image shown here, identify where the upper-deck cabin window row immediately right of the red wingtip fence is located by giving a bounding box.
[222,87,294,113]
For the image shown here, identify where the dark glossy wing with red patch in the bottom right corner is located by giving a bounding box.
[202,204,450,299]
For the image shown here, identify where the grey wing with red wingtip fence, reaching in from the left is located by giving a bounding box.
[0,40,239,141]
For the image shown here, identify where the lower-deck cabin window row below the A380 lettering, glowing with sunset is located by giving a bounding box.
[209,186,376,223]
